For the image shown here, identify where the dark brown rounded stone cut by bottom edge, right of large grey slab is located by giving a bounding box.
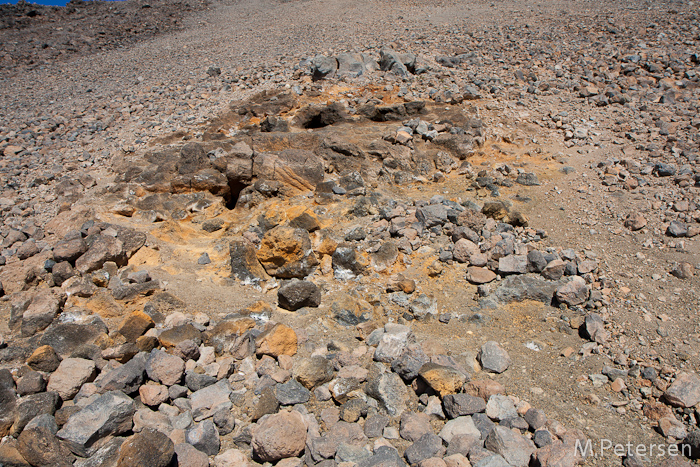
[117,428,175,467]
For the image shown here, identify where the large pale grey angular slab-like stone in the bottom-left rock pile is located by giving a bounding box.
[57,391,135,457]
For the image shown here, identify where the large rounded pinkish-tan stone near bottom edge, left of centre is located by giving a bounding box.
[251,412,306,462]
